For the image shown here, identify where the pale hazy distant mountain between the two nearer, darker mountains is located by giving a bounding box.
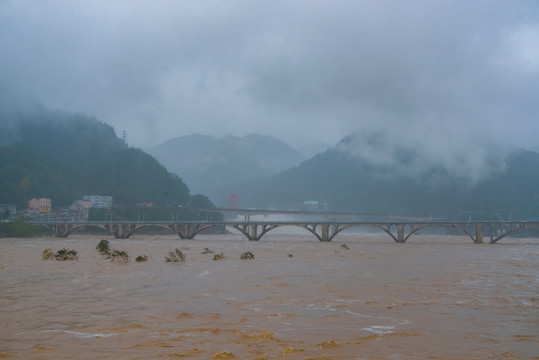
[147,134,303,193]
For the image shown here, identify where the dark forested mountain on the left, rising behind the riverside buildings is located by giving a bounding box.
[0,108,189,209]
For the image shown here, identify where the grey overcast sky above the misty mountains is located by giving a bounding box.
[0,0,539,158]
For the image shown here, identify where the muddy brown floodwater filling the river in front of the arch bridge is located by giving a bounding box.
[0,233,539,360]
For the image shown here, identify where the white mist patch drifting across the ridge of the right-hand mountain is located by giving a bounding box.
[335,128,519,185]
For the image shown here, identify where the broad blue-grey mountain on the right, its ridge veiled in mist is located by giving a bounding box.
[212,136,539,219]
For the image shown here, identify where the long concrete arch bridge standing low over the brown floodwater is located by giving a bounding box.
[31,221,539,244]
